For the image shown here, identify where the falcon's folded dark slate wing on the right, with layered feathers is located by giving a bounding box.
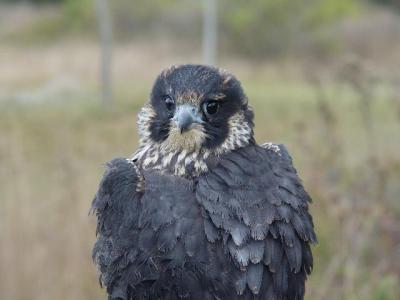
[196,144,316,300]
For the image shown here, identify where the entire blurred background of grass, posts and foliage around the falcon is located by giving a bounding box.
[0,0,400,300]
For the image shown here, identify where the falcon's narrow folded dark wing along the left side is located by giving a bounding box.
[92,158,142,299]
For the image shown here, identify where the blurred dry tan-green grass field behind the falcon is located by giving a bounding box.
[0,44,400,300]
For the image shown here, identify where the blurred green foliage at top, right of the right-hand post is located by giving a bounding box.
[220,0,360,55]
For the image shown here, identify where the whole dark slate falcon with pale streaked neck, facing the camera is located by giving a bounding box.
[92,65,316,300]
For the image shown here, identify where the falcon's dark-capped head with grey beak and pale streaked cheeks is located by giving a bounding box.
[138,65,253,155]
